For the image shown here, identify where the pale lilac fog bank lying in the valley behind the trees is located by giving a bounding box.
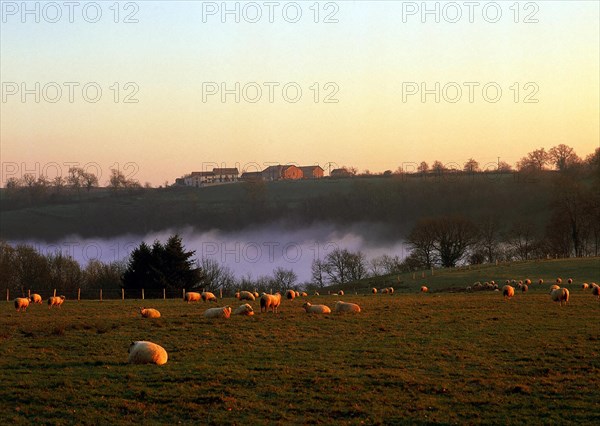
[9,223,408,282]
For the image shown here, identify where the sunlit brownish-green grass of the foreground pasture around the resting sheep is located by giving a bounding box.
[0,282,600,425]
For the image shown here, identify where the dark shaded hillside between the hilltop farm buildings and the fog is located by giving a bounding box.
[0,173,576,240]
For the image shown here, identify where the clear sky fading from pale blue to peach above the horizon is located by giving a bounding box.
[0,1,600,186]
